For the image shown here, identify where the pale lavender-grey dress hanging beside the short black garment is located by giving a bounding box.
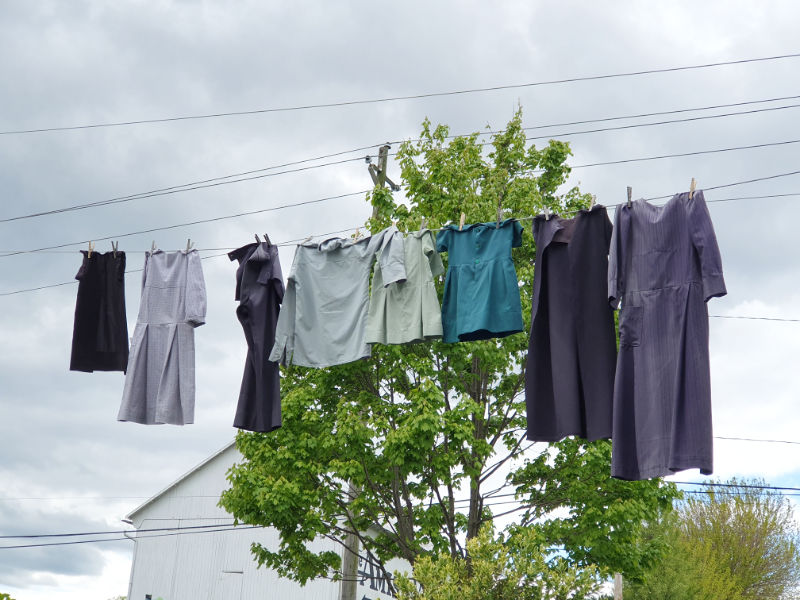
[117,250,206,425]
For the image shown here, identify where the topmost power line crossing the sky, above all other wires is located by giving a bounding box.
[0,53,800,135]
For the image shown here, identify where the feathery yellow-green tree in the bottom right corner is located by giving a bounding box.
[625,479,800,600]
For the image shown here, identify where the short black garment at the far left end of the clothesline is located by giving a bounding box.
[69,250,128,373]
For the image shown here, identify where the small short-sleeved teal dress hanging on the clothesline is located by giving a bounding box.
[436,219,523,342]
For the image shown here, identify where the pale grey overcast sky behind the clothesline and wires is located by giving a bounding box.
[0,0,800,600]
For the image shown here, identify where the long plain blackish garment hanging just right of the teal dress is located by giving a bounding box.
[525,205,617,442]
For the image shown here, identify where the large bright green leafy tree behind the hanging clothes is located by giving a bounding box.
[220,111,677,583]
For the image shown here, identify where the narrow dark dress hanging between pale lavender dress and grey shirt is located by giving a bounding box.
[228,242,284,432]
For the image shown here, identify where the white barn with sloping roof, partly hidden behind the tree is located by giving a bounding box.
[125,443,409,600]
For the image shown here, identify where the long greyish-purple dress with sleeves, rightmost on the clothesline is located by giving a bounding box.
[608,191,726,479]
